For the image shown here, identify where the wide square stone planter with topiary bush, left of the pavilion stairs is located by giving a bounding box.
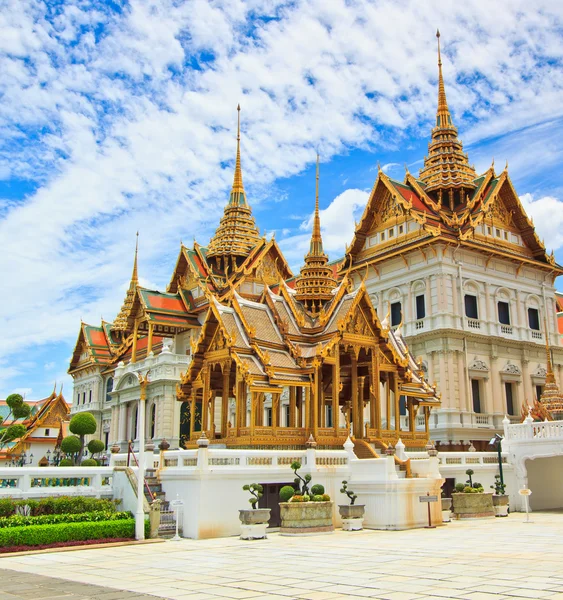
[280,461,334,535]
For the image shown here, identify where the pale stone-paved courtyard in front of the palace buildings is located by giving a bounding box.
[0,513,563,600]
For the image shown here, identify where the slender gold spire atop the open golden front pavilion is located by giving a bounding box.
[295,154,337,317]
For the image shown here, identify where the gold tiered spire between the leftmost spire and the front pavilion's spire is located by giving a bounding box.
[207,104,262,277]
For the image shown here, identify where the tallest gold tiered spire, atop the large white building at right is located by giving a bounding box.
[419,30,477,204]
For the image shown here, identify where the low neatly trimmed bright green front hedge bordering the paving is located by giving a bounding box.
[0,519,141,547]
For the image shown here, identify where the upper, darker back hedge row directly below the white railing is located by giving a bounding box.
[0,496,119,517]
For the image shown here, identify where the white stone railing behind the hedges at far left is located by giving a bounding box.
[0,467,113,498]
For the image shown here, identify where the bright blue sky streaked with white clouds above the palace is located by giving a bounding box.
[0,0,563,399]
